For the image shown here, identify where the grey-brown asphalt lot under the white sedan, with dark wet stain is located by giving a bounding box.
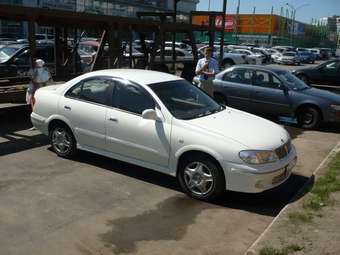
[0,95,340,255]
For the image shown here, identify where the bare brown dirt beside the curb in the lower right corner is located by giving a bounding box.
[246,147,340,255]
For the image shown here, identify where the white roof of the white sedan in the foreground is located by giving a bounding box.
[85,69,182,85]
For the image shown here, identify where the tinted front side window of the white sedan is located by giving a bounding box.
[113,81,155,114]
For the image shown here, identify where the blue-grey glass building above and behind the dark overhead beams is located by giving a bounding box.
[0,0,199,36]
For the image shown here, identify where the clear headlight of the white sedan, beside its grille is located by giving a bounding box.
[239,150,278,164]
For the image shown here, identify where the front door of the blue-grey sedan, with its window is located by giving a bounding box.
[252,70,292,116]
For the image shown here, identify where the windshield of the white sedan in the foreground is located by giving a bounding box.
[149,80,225,120]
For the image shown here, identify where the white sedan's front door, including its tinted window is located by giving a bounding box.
[105,80,171,167]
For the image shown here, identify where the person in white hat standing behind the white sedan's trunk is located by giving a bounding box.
[26,59,51,130]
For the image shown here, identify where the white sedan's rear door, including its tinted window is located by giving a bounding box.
[59,77,113,150]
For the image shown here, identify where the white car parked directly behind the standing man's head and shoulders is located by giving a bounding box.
[198,45,246,69]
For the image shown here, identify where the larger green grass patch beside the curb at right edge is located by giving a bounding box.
[288,153,340,224]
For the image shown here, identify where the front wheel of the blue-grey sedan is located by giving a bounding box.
[297,107,321,129]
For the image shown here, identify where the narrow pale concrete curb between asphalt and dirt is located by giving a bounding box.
[243,142,340,255]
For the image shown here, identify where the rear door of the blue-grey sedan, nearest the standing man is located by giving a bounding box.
[216,68,253,112]
